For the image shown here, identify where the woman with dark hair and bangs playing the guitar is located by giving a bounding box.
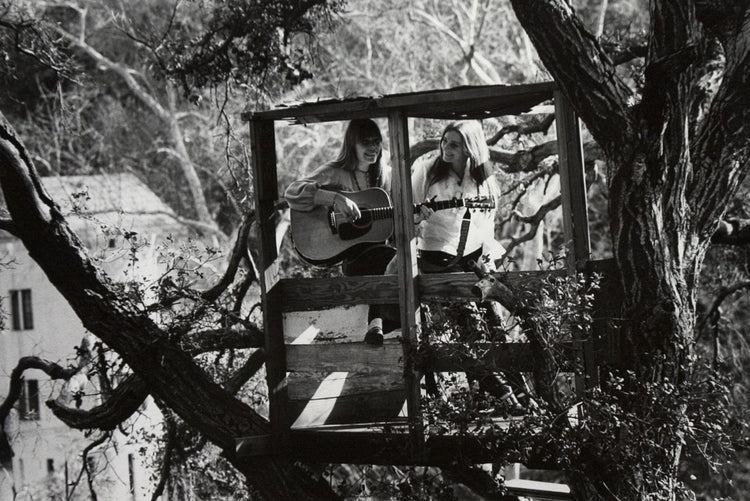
[284,119,396,345]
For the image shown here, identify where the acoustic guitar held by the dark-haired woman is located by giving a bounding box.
[291,188,495,266]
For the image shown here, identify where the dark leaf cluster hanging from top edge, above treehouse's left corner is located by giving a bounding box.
[153,0,352,95]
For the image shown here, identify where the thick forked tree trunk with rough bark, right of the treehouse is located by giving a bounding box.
[512,0,750,499]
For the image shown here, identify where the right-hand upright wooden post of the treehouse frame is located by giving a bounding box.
[554,90,599,392]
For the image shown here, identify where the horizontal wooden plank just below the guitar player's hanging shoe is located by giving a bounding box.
[286,343,404,374]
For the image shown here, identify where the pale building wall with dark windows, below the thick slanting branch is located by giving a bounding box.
[0,241,160,501]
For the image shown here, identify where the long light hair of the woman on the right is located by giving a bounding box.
[427,120,490,188]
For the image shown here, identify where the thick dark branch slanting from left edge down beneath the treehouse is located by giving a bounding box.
[0,110,340,499]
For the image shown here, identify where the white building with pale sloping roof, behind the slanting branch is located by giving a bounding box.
[0,174,194,501]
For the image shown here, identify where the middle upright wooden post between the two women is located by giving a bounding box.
[388,109,424,457]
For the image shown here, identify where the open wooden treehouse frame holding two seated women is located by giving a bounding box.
[237,83,617,486]
